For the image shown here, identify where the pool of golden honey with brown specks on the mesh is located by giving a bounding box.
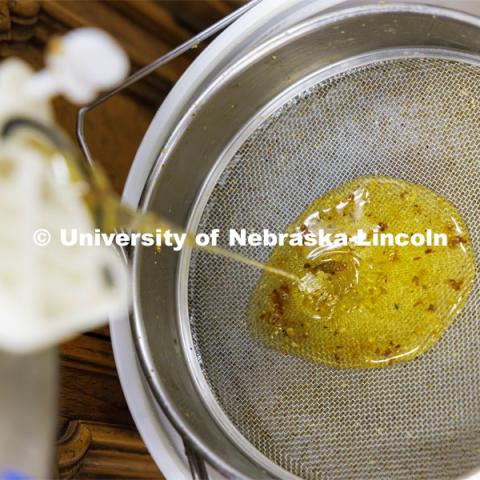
[250,177,476,368]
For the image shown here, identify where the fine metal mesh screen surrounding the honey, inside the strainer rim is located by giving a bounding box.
[189,58,480,479]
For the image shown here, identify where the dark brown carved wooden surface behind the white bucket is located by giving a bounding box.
[0,0,243,479]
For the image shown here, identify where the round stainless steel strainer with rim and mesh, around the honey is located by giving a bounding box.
[82,1,480,479]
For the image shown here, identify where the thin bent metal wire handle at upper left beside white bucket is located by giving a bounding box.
[76,0,263,165]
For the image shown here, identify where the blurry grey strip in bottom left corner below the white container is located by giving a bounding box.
[0,348,59,478]
